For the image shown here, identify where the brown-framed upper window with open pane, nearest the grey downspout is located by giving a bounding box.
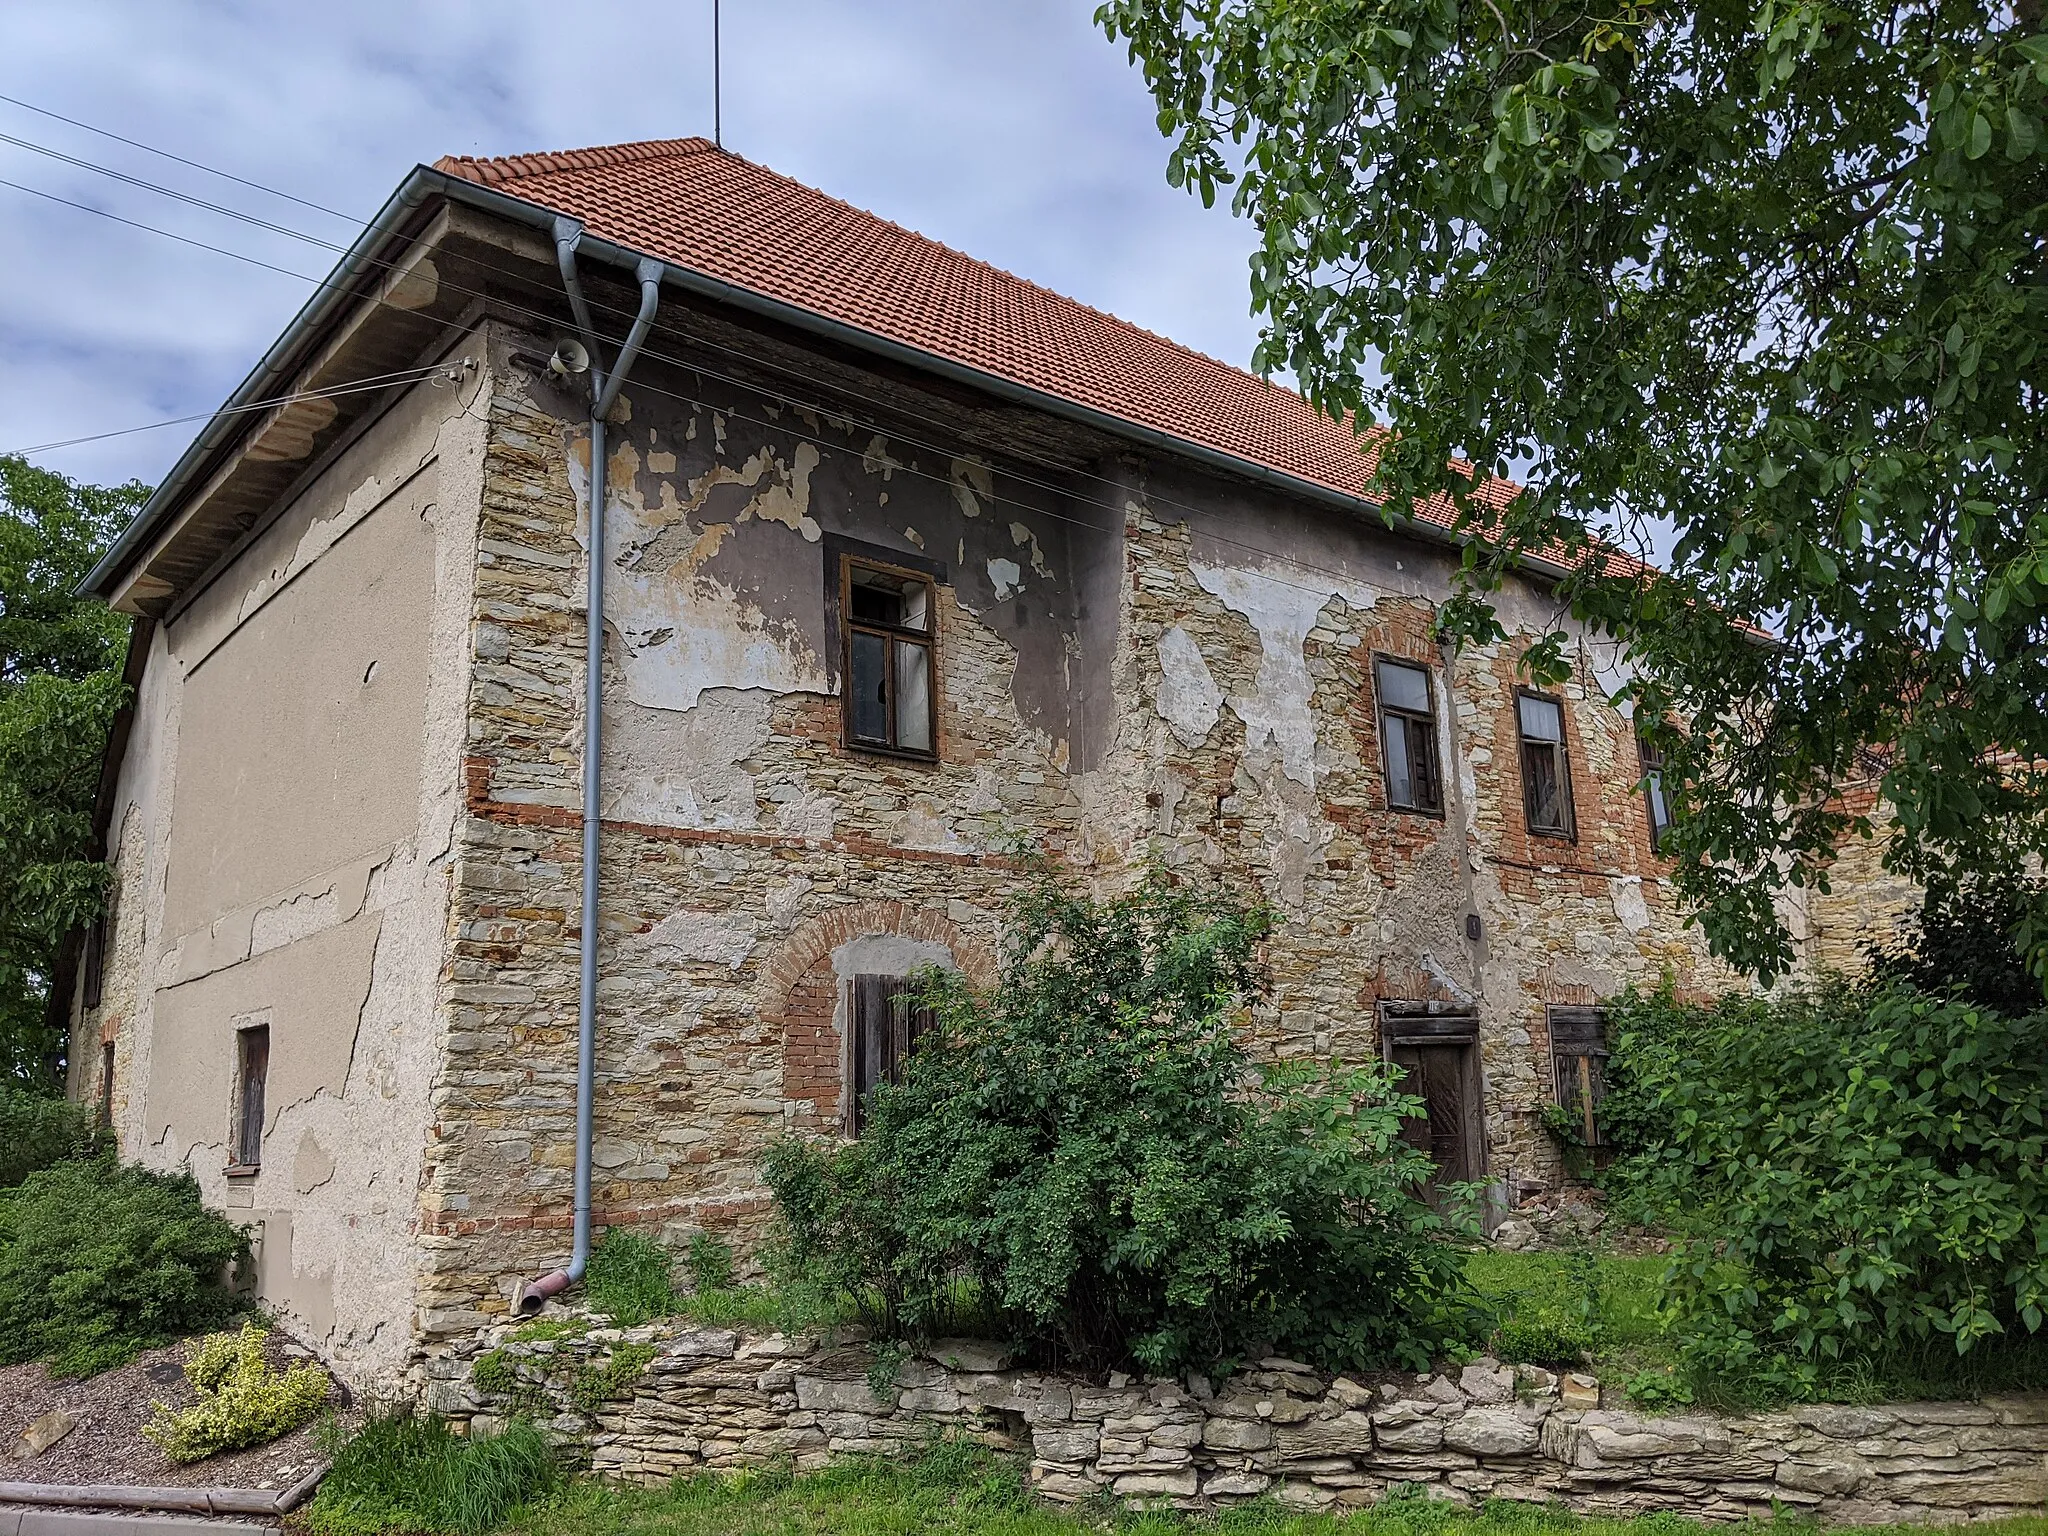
[840,555,938,758]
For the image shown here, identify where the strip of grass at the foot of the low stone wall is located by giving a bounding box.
[499,1442,2048,1536]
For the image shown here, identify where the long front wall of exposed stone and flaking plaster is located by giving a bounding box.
[422,315,1731,1337]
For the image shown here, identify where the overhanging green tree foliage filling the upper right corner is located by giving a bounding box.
[1098,0,2048,975]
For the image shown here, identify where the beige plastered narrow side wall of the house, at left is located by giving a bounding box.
[74,358,489,1382]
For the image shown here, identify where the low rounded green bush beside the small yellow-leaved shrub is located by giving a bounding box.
[0,1155,250,1376]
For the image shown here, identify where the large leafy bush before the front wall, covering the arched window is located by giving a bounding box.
[764,870,1466,1372]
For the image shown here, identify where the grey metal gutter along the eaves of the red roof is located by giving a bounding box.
[80,166,1571,596]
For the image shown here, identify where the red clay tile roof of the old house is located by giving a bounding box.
[434,139,1440,520]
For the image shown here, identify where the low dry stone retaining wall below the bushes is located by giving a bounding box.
[422,1325,2048,1524]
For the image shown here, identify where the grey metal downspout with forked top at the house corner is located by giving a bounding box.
[518,219,666,1315]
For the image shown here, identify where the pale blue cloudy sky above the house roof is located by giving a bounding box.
[0,0,1255,481]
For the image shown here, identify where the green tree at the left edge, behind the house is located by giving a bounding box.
[0,457,150,1087]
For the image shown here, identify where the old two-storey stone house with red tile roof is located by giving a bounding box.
[66,139,1851,1378]
